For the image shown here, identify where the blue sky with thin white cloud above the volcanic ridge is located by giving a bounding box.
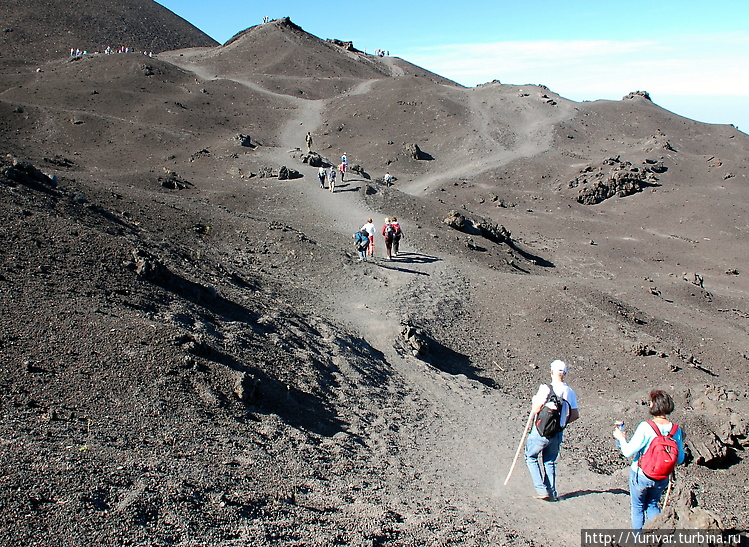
[159,0,749,132]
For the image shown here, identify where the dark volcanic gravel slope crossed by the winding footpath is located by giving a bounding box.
[0,10,749,545]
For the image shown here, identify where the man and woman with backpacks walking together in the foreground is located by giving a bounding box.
[520,360,684,530]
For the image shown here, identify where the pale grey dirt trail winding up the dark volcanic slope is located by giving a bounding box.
[167,64,629,545]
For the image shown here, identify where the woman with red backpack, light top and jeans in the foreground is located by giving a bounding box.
[614,389,684,530]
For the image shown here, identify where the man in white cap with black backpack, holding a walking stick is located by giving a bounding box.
[525,359,580,501]
